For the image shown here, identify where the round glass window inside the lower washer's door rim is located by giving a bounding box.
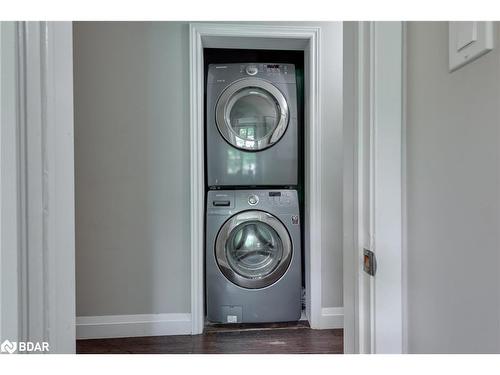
[226,221,283,279]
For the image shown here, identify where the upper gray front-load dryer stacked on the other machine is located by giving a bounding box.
[206,63,298,187]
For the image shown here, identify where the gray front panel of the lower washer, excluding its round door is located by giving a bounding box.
[205,189,302,323]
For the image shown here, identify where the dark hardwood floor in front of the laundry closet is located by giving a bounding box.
[76,322,344,354]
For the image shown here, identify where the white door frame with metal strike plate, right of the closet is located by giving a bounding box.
[344,22,404,353]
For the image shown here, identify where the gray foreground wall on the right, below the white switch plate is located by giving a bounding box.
[407,22,500,353]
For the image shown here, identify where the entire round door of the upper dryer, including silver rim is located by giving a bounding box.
[215,78,289,151]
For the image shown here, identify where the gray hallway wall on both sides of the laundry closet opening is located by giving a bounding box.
[74,22,342,316]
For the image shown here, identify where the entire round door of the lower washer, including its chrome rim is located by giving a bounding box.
[215,210,292,289]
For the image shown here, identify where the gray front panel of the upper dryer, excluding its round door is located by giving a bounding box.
[206,64,298,187]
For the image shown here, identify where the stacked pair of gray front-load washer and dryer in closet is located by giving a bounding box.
[205,63,302,323]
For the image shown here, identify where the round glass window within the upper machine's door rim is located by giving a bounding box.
[226,87,281,143]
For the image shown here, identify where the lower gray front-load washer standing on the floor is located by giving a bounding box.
[205,190,302,323]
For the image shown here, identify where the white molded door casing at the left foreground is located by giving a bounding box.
[6,21,76,353]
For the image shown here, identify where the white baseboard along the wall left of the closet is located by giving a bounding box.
[76,314,192,339]
